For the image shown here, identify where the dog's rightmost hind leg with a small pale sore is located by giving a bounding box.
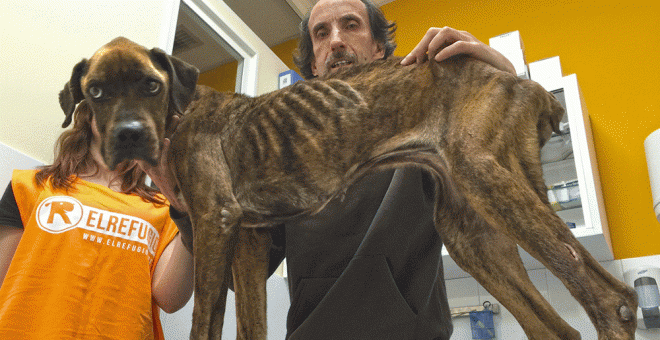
[451,153,637,340]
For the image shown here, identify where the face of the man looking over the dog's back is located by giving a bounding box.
[308,0,385,76]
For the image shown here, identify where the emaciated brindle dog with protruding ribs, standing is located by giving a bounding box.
[61,38,637,340]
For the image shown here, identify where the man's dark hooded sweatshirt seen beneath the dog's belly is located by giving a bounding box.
[270,169,452,340]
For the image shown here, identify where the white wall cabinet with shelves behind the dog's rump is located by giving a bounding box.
[442,74,614,279]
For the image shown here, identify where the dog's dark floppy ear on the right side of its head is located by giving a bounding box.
[151,48,199,113]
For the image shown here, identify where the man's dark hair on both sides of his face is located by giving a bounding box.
[293,0,396,79]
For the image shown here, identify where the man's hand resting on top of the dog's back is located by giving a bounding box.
[401,27,516,75]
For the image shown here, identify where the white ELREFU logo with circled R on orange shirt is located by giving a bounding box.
[37,196,160,256]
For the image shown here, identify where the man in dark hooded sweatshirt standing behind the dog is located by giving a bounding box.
[150,0,515,340]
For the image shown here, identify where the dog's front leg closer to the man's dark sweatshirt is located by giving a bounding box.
[232,228,271,340]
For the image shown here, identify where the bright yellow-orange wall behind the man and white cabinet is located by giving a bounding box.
[273,0,660,259]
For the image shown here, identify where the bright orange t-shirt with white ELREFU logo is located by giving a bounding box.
[0,170,177,340]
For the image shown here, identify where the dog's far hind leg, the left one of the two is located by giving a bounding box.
[436,206,580,340]
